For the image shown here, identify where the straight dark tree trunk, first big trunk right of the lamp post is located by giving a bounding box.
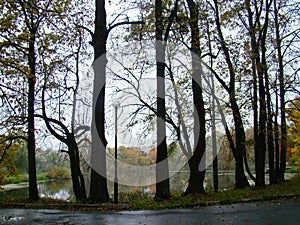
[155,0,170,199]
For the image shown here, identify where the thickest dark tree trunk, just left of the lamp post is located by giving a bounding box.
[89,0,109,202]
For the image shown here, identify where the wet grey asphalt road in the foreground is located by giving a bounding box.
[0,198,300,225]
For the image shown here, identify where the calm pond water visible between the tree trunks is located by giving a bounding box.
[0,171,293,201]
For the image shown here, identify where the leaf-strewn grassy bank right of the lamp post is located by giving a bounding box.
[120,175,300,210]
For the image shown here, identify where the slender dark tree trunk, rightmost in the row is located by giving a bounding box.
[274,0,287,181]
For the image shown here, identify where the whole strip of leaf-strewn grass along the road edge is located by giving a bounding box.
[0,175,300,210]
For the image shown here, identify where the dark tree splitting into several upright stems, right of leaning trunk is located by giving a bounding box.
[245,0,274,186]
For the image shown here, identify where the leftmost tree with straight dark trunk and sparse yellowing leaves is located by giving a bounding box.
[1,0,87,200]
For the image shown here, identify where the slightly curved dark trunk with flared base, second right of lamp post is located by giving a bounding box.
[185,0,206,194]
